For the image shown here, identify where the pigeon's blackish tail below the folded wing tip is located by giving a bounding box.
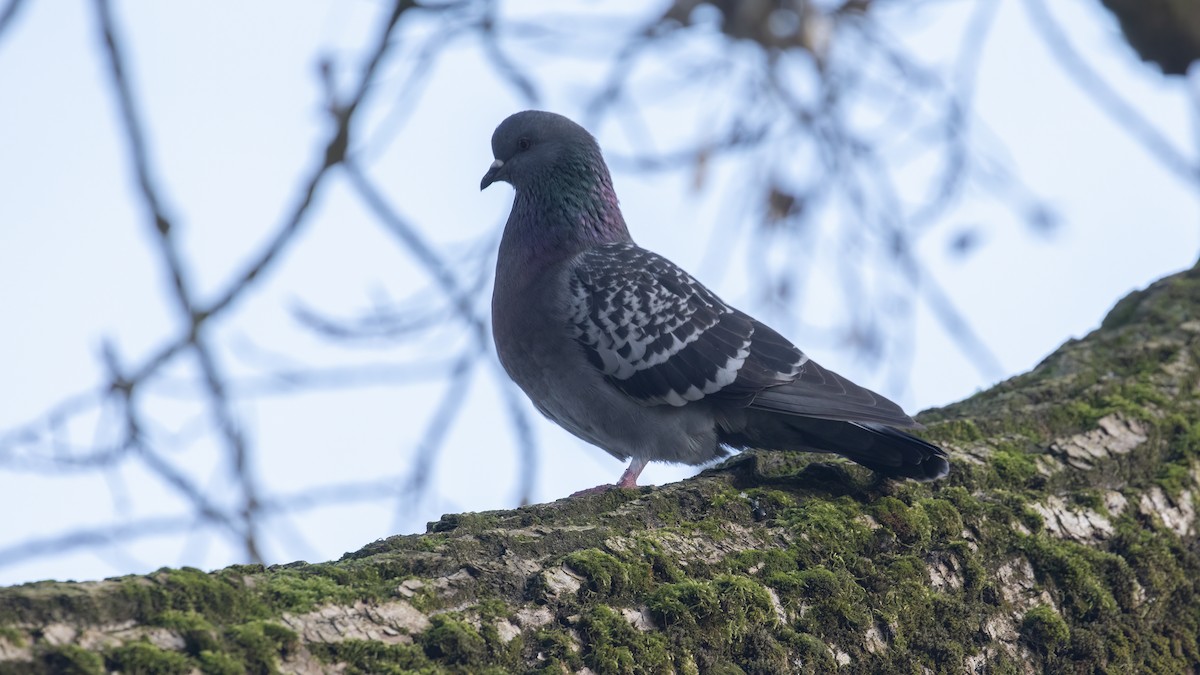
[721,411,950,480]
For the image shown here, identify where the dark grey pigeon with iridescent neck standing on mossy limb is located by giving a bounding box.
[480,110,950,492]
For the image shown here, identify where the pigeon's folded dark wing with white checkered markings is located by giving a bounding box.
[569,243,914,426]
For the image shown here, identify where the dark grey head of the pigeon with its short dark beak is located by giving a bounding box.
[479,110,608,191]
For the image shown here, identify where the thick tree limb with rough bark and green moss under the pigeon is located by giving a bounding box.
[0,260,1200,674]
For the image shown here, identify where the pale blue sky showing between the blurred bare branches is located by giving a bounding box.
[0,0,1200,584]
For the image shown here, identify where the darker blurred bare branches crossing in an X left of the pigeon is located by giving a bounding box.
[0,0,414,561]
